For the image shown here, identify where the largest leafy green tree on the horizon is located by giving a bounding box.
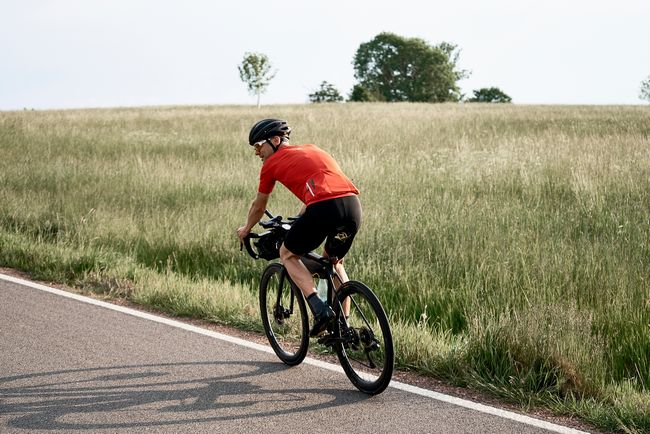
[350,33,468,102]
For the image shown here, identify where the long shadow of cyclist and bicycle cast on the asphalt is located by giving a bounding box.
[0,361,368,430]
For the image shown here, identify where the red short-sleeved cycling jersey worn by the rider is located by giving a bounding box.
[258,145,359,205]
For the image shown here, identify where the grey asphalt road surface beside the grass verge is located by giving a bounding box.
[0,276,577,433]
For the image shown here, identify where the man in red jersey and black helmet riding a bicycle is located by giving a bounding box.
[237,119,361,336]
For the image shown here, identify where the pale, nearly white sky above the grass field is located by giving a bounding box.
[0,0,650,110]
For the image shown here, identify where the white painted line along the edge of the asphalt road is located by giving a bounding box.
[0,274,585,434]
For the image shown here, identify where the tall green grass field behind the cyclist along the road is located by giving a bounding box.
[0,104,650,432]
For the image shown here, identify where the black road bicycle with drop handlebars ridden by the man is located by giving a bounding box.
[243,210,394,395]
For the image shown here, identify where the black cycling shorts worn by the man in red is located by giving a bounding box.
[284,196,361,259]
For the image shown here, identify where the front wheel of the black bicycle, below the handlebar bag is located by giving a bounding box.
[260,264,309,366]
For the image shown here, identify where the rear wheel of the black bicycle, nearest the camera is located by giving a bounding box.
[334,281,394,395]
